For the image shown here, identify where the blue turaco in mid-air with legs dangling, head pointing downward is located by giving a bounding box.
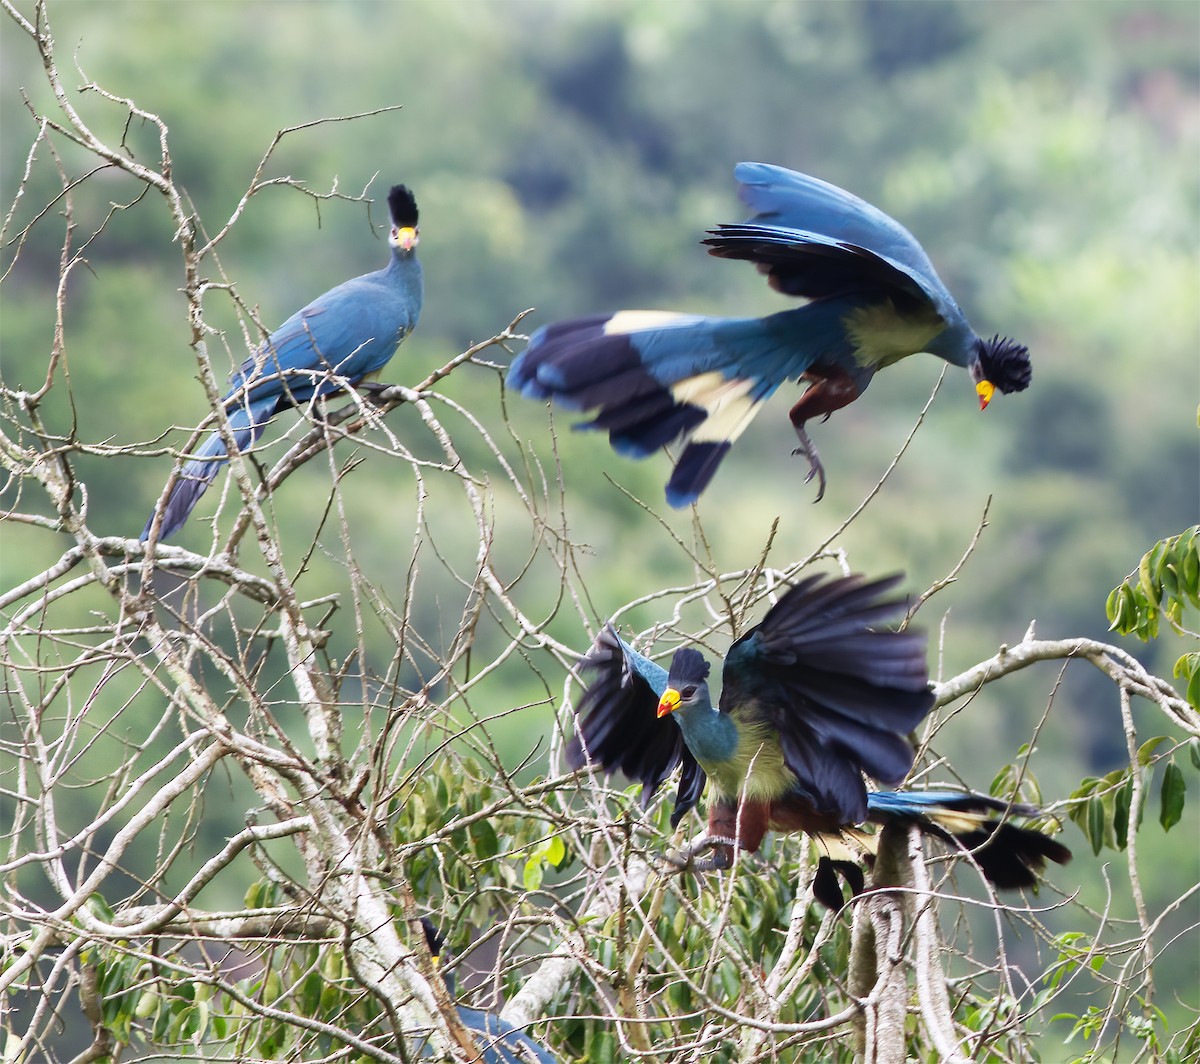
[508,162,1031,506]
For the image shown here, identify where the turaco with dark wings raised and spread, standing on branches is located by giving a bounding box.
[566,576,1070,909]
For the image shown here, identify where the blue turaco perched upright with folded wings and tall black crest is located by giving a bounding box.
[142,185,422,540]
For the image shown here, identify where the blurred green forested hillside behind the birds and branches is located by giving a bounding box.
[0,0,1200,1060]
